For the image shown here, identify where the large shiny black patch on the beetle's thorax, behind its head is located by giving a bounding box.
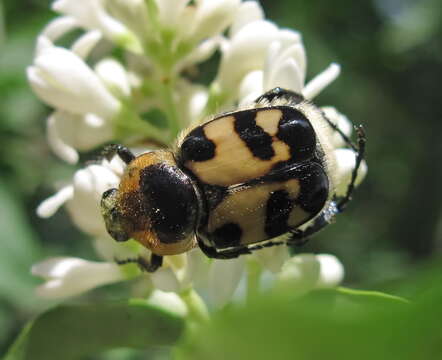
[140,164,198,244]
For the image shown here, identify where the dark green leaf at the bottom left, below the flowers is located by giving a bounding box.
[4,299,184,360]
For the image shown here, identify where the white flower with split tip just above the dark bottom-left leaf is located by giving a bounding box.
[31,257,126,299]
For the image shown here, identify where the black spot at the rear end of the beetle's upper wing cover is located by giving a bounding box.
[276,106,316,162]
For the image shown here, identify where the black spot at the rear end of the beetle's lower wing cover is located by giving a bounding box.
[296,162,329,216]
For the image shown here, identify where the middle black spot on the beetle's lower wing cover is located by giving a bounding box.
[264,190,294,238]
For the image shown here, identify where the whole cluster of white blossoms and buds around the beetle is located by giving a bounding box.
[27,0,366,305]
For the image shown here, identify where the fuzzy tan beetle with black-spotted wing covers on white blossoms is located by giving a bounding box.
[101,88,366,272]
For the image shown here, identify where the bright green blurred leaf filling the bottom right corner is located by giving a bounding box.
[175,285,442,360]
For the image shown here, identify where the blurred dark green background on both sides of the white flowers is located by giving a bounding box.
[0,0,442,353]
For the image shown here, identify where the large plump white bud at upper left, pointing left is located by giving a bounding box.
[27,46,120,118]
